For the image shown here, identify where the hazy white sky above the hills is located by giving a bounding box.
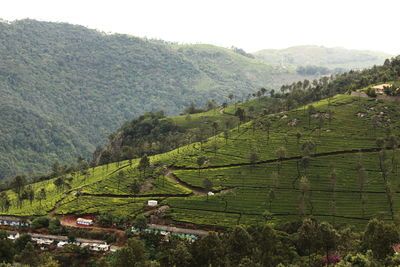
[0,0,400,54]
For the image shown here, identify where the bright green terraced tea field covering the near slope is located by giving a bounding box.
[1,95,400,230]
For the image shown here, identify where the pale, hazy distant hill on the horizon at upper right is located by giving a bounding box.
[253,45,393,70]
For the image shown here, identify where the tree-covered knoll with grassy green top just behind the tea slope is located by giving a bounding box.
[94,93,274,164]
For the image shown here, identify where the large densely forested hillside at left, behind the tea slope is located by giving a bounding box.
[0,20,320,179]
